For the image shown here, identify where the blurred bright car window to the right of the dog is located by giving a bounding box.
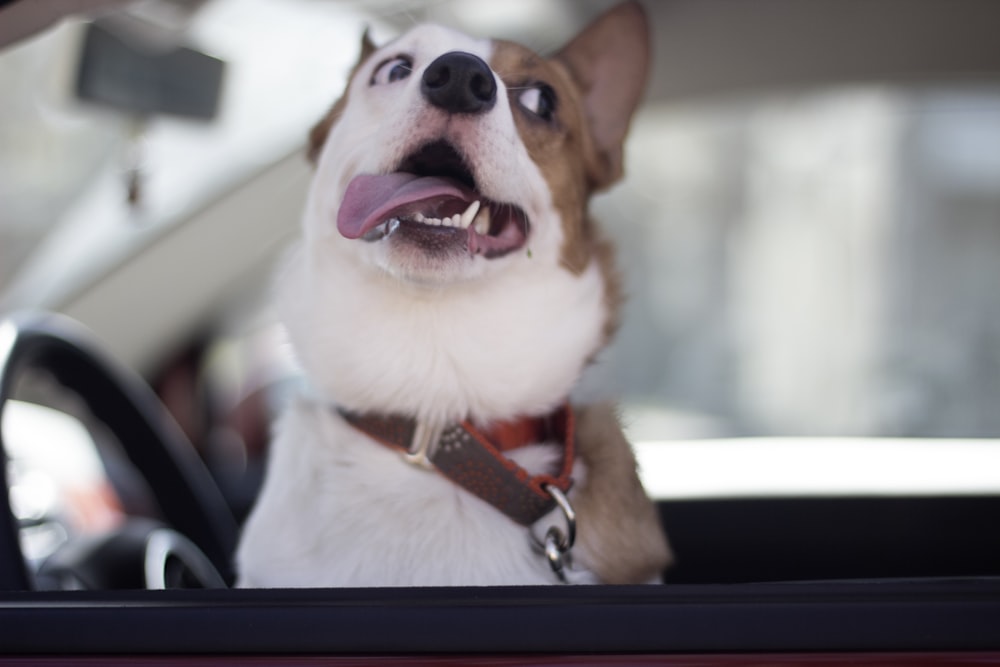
[593,84,1000,438]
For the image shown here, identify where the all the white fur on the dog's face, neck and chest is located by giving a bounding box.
[238,26,606,587]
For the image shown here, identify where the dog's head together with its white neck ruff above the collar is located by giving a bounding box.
[286,3,648,417]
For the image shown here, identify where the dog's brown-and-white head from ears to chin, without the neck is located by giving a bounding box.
[310,4,647,284]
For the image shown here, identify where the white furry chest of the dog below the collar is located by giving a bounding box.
[238,402,576,587]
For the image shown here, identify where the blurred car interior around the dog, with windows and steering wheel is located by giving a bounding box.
[0,0,1000,654]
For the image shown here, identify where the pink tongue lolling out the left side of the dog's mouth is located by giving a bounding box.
[337,172,472,239]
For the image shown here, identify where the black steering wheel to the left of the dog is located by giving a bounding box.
[0,313,237,590]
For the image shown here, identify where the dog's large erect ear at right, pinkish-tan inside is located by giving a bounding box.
[555,1,650,187]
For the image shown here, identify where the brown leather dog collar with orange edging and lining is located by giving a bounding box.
[340,405,575,526]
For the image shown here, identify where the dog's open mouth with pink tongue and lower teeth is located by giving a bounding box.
[337,141,529,259]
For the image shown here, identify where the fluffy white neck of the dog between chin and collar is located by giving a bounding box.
[279,241,606,423]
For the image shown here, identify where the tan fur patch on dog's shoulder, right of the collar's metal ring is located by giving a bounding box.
[572,404,672,584]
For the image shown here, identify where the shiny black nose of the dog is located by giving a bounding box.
[420,51,497,113]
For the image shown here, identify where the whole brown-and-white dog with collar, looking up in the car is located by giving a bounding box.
[237,2,670,587]
